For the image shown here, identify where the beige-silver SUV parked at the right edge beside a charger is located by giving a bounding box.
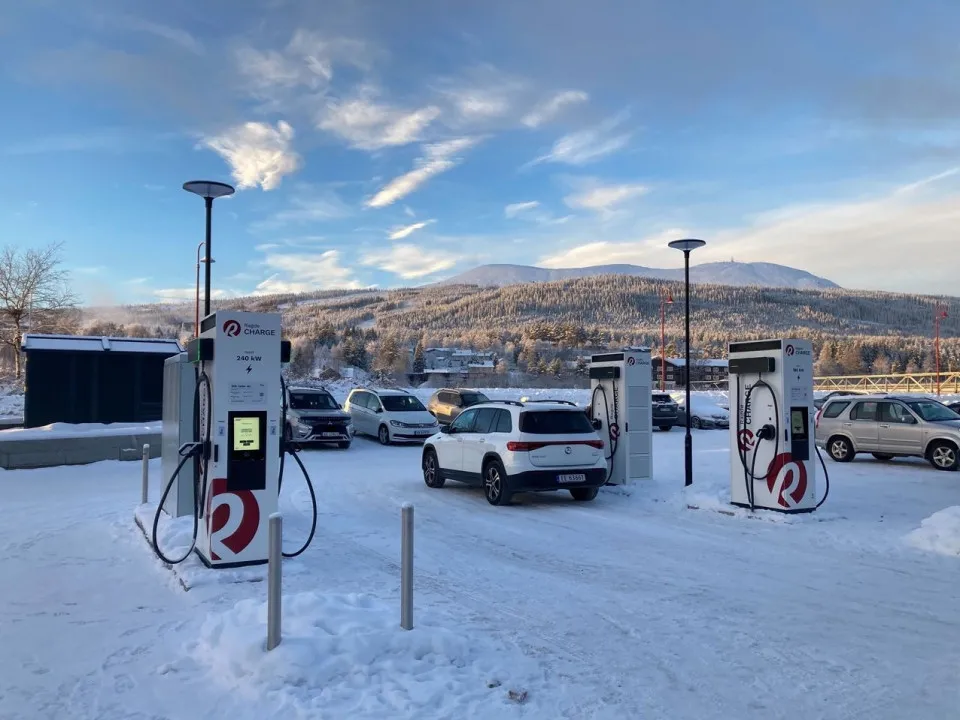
[814,395,960,470]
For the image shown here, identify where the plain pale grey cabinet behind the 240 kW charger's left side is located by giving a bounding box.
[160,352,198,517]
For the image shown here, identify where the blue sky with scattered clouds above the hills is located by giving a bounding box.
[0,0,960,304]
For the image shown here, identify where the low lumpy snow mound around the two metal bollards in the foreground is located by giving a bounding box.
[191,592,547,720]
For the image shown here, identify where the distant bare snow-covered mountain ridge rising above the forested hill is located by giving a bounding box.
[441,262,840,289]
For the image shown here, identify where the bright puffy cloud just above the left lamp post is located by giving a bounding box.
[202,120,301,190]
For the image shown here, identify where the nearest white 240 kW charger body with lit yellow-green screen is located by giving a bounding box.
[197,310,281,567]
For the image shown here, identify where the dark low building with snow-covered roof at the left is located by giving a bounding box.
[21,335,182,427]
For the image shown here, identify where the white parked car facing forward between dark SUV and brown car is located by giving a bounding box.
[344,388,438,445]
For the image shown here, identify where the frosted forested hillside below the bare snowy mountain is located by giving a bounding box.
[88,276,960,374]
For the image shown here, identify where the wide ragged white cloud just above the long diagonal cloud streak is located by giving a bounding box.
[317,88,440,150]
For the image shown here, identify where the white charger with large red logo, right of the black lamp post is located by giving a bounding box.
[728,339,826,513]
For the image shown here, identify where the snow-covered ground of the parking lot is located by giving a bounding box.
[0,416,960,720]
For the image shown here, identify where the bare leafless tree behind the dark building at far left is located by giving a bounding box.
[0,243,79,380]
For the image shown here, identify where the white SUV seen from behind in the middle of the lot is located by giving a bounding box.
[422,401,607,505]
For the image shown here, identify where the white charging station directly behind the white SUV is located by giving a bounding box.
[588,348,653,485]
